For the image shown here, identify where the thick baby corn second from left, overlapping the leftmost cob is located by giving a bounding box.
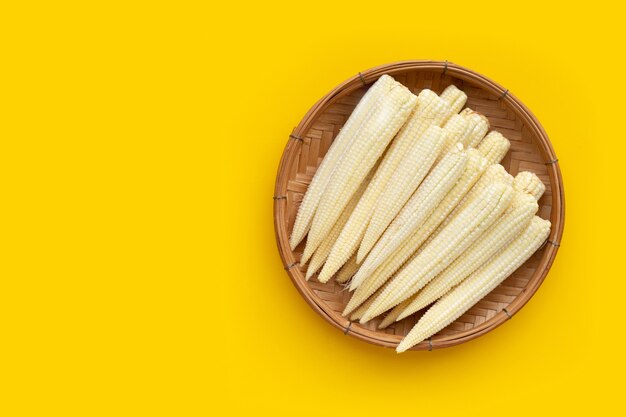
[307,79,417,251]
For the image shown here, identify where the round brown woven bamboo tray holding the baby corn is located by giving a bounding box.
[274,61,565,350]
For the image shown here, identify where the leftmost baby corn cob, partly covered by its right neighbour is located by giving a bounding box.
[289,75,395,250]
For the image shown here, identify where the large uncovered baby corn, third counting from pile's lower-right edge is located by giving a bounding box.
[361,182,513,323]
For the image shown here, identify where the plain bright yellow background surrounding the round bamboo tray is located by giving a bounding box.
[0,0,626,416]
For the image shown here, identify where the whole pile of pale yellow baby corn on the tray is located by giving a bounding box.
[290,75,550,352]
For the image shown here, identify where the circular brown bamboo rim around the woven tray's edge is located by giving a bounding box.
[274,60,565,350]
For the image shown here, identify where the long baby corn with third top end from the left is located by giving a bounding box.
[319,89,450,280]
